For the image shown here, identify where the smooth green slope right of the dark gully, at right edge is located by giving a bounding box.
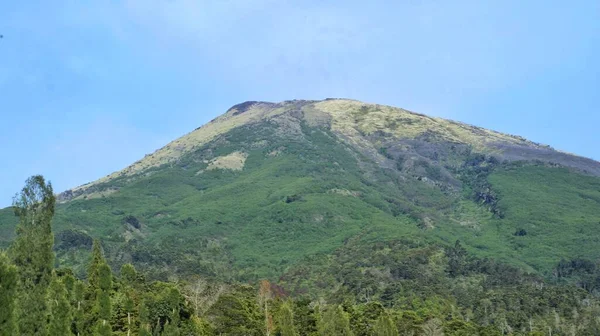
[489,166,600,271]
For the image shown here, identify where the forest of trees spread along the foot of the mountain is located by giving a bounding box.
[0,176,600,336]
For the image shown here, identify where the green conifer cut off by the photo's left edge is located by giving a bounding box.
[0,252,17,336]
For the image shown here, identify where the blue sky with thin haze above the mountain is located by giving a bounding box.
[0,0,600,206]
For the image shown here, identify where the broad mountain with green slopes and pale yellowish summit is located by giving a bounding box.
[0,99,600,281]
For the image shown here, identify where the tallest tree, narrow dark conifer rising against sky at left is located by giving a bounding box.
[10,175,56,336]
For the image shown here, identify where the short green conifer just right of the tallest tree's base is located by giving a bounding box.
[48,276,72,335]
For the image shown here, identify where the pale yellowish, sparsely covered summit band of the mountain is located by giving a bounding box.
[63,98,600,199]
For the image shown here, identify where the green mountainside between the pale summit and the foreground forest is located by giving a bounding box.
[0,120,600,281]
